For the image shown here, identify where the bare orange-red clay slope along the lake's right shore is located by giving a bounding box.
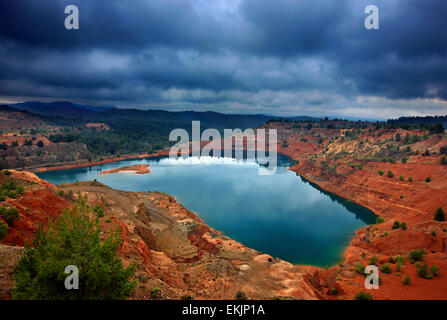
[262,123,447,300]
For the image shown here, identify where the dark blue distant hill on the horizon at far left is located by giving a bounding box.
[11,101,115,118]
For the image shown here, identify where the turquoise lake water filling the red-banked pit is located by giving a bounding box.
[39,156,375,266]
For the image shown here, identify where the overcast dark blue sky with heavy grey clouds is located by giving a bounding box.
[0,0,447,118]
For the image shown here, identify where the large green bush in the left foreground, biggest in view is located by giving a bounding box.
[13,197,136,300]
